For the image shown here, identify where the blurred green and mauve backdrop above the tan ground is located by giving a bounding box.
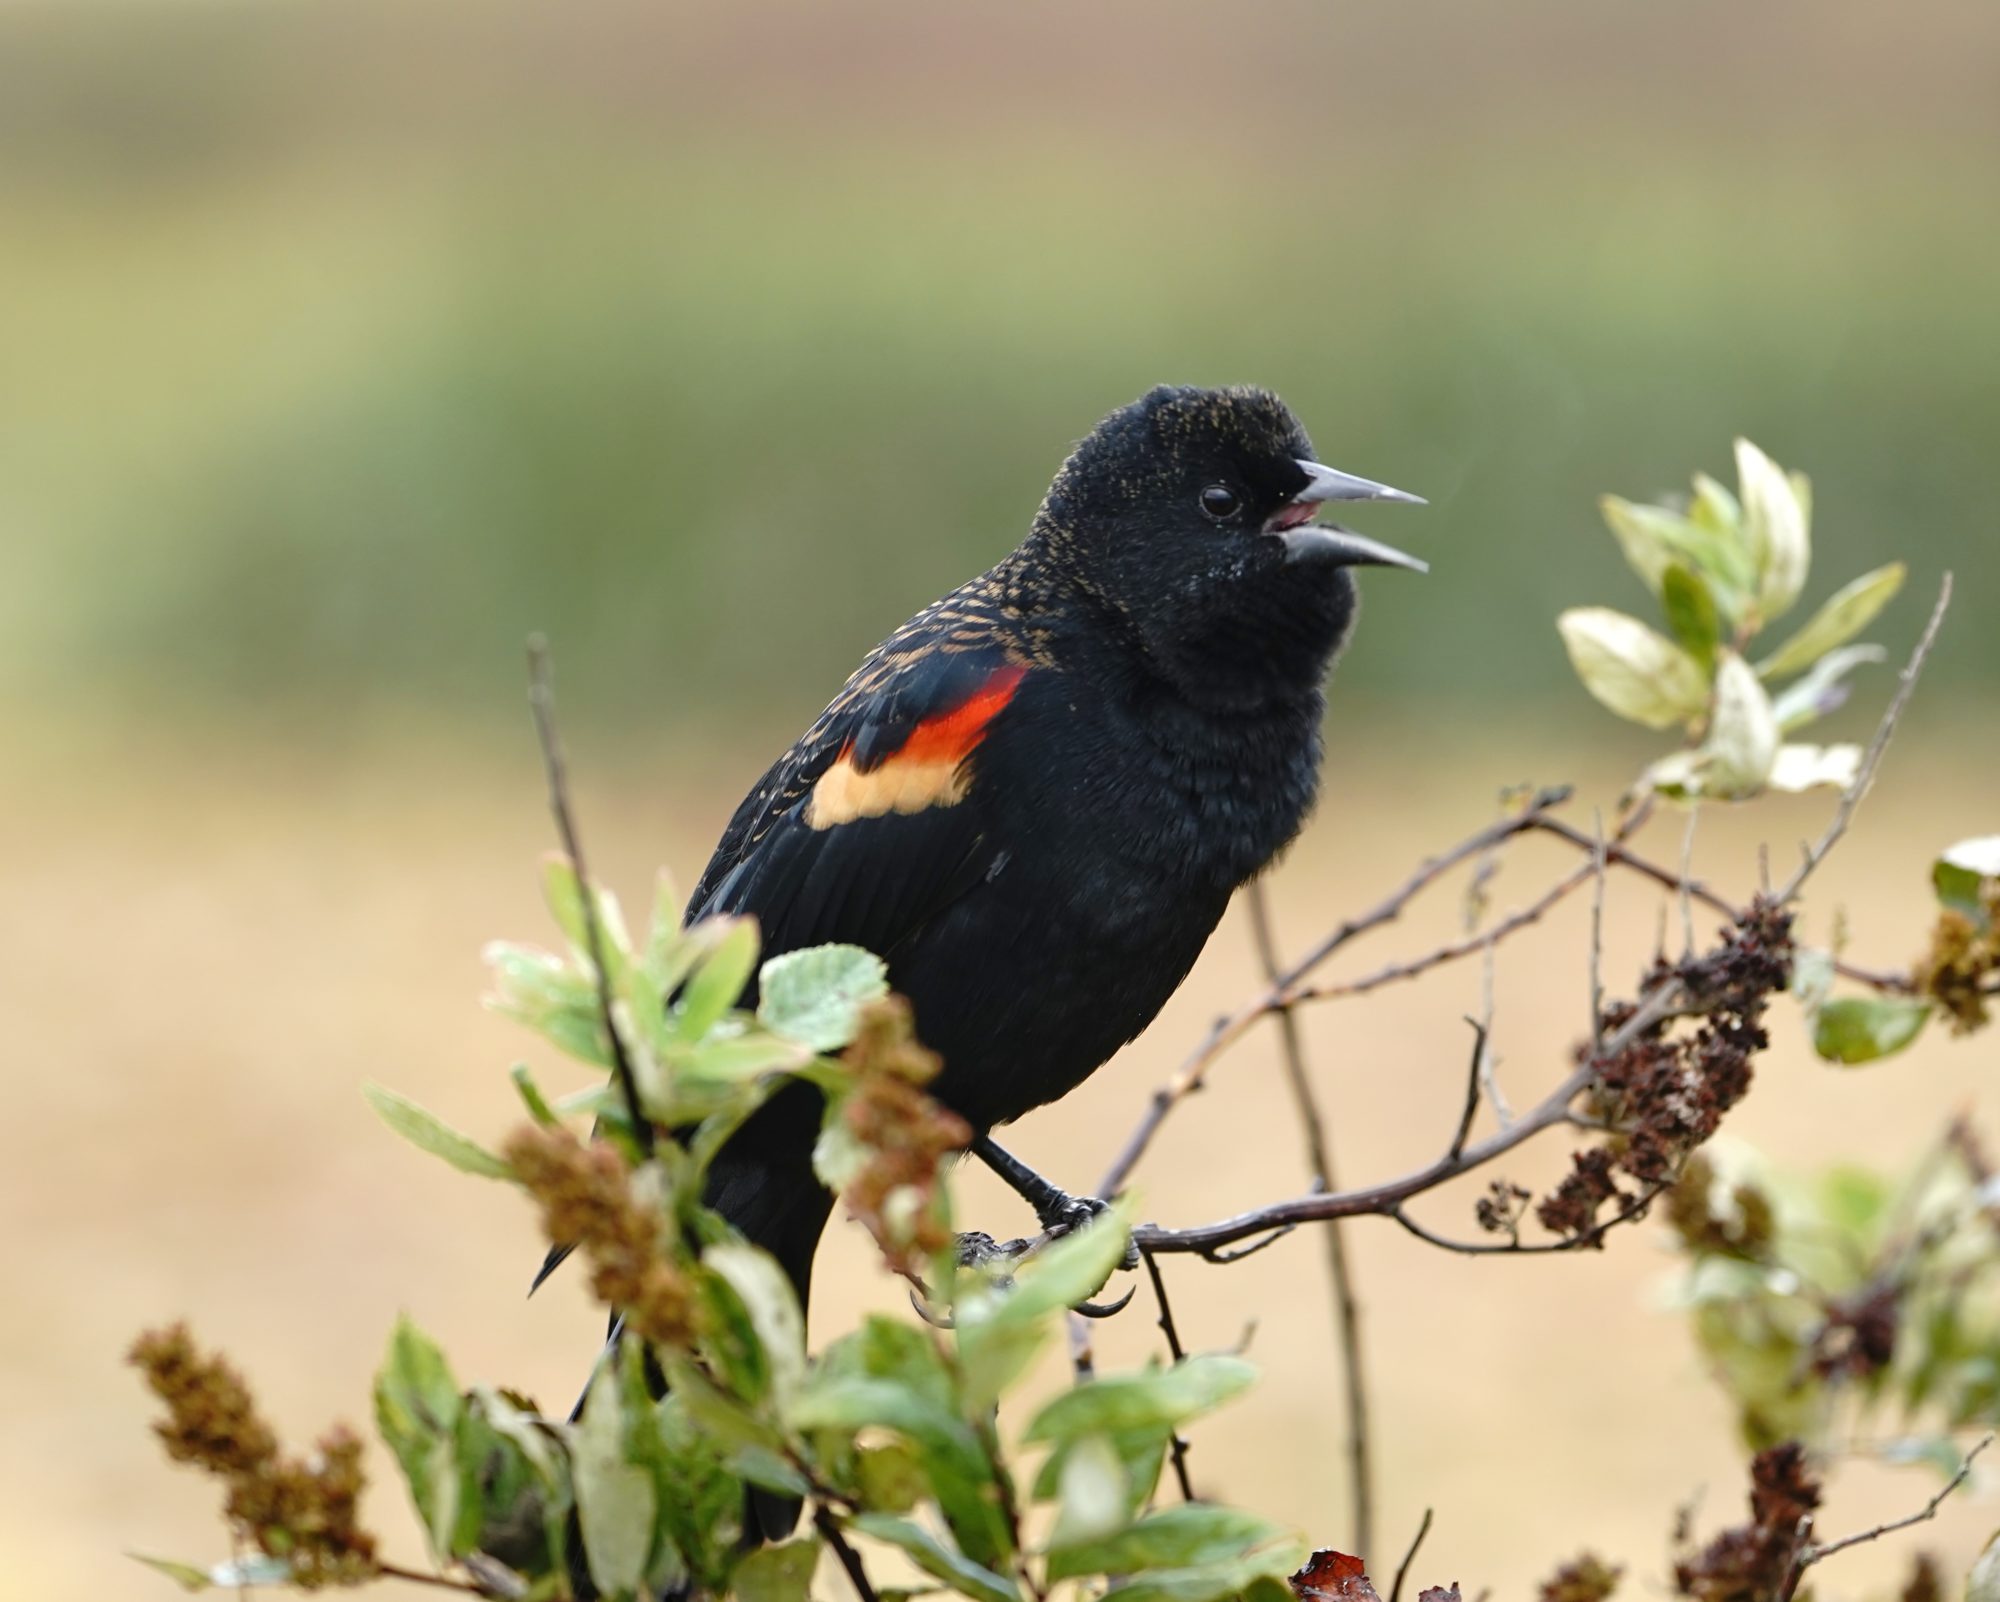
[0,0,2000,732]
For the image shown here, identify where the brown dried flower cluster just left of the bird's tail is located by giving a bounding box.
[500,1124,698,1346]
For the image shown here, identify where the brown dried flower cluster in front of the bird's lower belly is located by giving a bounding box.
[842,996,972,1276]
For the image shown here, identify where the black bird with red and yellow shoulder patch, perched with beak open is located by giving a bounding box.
[544,388,1424,1534]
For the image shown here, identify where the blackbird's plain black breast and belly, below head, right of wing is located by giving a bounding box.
[890,672,1320,1128]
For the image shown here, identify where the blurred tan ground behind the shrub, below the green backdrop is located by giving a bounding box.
[0,702,2000,1596]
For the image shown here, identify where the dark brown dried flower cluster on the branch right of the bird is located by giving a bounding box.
[1536,900,1792,1238]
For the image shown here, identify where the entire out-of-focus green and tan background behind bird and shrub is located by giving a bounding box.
[0,0,2000,1596]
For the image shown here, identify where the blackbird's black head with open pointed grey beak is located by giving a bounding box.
[1036,386,1426,700]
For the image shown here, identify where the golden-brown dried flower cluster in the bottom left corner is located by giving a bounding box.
[128,1324,376,1590]
